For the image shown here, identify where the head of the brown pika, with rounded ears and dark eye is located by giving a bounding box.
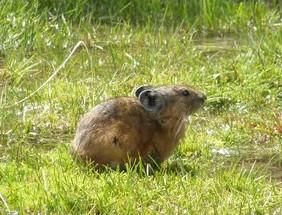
[135,85,206,121]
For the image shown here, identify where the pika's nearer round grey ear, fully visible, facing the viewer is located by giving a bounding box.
[138,90,165,113]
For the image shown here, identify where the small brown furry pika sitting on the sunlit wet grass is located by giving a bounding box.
[72,85,206,167]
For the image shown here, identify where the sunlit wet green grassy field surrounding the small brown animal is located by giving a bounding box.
[0,0,282,214]
